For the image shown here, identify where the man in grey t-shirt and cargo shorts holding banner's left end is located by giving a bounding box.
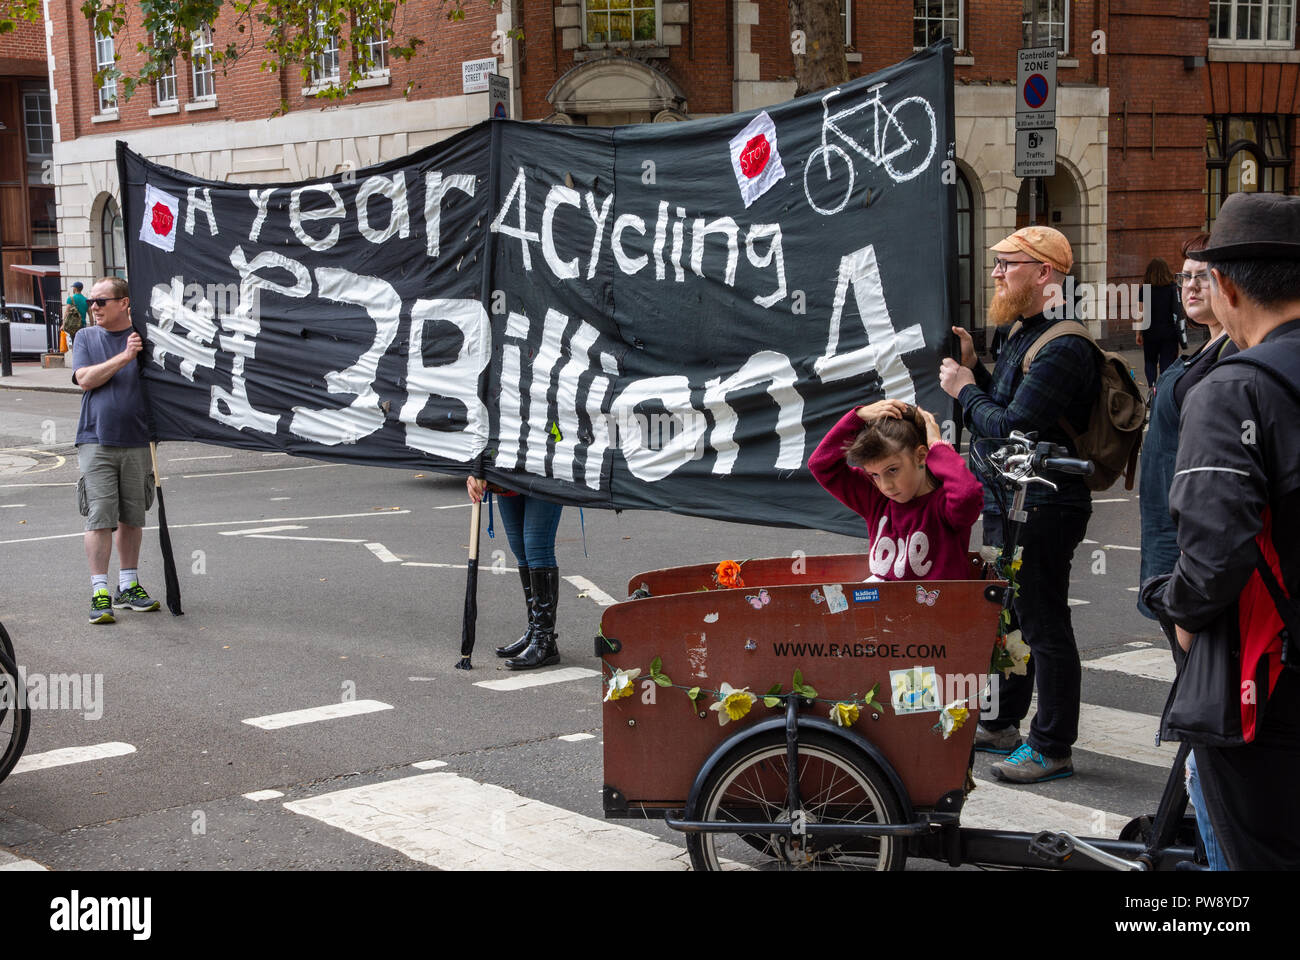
[73,277,159,623]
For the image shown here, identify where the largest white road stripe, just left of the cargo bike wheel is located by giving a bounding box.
[285,773,686,870]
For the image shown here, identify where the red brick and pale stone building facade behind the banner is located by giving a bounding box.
[48,0,1300,343]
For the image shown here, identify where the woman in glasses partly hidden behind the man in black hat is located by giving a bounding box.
[1138,233,1236,870]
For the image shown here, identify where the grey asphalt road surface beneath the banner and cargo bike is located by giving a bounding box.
[0,389,1167,870]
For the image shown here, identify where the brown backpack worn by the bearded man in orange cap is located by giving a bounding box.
[1011,320,1147,490]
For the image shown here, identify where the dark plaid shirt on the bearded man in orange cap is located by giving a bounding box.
[957,313,1101,506]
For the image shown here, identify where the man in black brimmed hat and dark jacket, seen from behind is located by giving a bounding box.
[1161,194,1300,870]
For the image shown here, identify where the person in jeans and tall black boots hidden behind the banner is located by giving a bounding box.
[465,476,564,670]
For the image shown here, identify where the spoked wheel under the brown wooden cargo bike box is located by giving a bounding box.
[686,730,907,870]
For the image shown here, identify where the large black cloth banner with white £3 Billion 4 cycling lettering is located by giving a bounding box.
[118,44,956,535]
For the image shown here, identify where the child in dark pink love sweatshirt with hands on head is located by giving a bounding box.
[809,399,984,580]
